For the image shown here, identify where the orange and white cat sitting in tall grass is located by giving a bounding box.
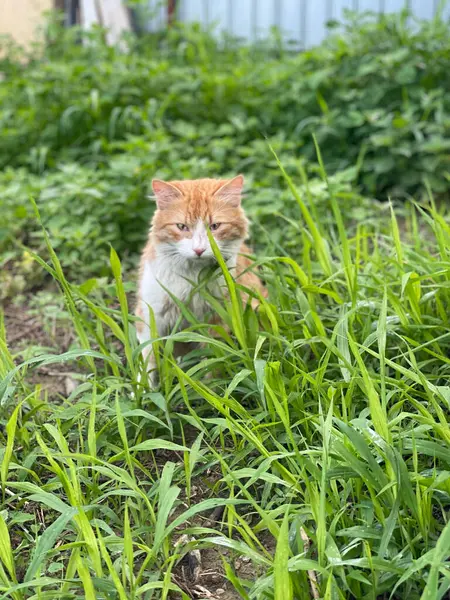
[136,175,267,384]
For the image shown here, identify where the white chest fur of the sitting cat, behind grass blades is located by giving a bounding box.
[140,258,213,335]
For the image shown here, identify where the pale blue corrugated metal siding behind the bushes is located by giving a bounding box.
[143,0,450,47]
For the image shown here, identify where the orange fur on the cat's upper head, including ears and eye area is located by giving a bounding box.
[152,175,248,242]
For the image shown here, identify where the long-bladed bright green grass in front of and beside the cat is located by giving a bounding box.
[0,154,450,600]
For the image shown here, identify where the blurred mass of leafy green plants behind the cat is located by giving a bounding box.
[0,8,450,295]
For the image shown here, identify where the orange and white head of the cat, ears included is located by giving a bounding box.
[152,175,248,264]
